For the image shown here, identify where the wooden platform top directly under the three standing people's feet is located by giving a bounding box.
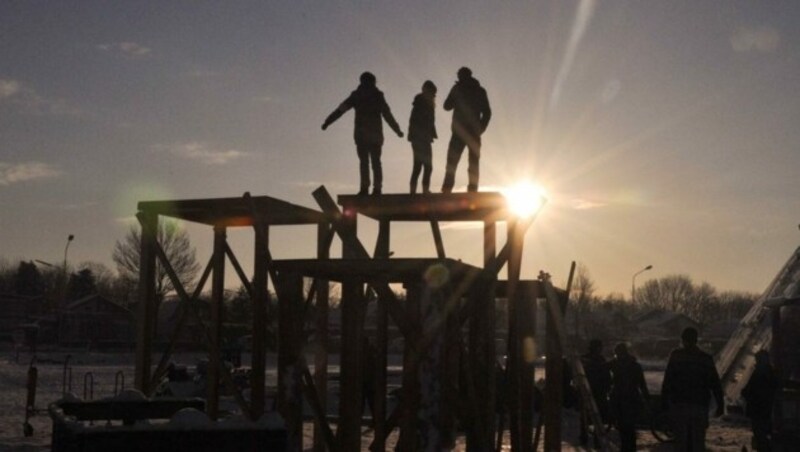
[338,192,513,221]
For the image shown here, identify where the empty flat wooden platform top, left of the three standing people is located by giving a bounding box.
[138,196,326,227]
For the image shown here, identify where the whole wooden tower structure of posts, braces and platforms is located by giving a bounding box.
[136,187,551,451]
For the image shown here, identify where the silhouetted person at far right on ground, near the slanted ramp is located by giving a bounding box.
[742,350,778,452]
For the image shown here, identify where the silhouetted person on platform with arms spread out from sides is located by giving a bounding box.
[322,72,403,195]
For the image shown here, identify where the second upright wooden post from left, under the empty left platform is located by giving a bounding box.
[206,226,226,419]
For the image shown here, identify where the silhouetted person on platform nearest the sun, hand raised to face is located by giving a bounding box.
[442,67,492,193]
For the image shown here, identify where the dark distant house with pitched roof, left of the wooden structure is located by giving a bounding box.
[57,294,136,346]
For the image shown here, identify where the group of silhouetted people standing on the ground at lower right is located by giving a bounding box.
[581,327,778,452]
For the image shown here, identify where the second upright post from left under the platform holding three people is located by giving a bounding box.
[374,220,390,450]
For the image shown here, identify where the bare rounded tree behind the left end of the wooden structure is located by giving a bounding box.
[111,219,200,306]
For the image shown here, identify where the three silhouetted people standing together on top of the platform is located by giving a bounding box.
[322,67,492,195]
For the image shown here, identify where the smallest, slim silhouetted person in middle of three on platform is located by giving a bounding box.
[408,80,438,195]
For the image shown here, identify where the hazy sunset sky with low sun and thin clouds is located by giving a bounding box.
[0,0,800,296]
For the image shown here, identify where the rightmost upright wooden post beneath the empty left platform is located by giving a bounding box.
[314,223,330,452]
